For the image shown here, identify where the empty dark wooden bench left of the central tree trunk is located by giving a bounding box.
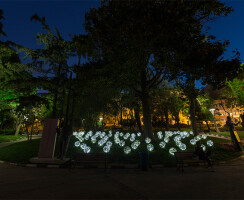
[73,153,108,169]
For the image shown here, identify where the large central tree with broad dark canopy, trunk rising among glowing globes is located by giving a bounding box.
[85,0,234,137]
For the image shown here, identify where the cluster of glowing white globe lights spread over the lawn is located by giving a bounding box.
[73,131,213,155]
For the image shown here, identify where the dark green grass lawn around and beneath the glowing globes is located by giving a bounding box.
[0,137,242,164]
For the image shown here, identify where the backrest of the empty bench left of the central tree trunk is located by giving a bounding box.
[74,153,107,161]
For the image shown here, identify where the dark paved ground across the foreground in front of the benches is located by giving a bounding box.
[0,160,244,199]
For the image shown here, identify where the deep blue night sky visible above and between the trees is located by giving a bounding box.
[0,0,244,66]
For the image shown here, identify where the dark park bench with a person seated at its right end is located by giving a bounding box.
[174,152,205,172]
